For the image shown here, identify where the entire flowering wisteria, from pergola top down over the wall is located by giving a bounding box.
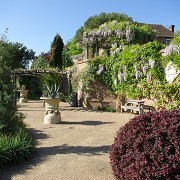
[75,20,180,109]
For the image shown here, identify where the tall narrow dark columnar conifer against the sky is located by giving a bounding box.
[50,34,64,70]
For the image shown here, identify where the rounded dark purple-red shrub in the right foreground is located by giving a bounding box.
[110,110,180,180]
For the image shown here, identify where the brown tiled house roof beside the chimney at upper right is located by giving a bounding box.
[148,24,174,37]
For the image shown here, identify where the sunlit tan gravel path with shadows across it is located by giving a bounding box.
[0,100,134,180]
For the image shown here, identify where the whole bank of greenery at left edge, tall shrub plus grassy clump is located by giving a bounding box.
[0,40,34,169]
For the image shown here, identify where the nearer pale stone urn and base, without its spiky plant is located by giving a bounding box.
[41,98,61,124]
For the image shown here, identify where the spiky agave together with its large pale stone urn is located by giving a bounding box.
[41,84,61,124]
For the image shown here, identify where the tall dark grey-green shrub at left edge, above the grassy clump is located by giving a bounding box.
[0,41,16,134]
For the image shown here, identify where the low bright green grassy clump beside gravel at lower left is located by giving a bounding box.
[0,112,35,169]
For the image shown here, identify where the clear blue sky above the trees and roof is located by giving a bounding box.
[0,0,180,55]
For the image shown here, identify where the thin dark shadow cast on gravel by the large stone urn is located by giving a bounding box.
[61,121,114,126]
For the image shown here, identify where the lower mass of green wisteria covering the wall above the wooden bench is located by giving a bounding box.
[80,41,180,109]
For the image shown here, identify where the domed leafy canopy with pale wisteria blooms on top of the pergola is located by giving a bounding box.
[71,13,154,57]
